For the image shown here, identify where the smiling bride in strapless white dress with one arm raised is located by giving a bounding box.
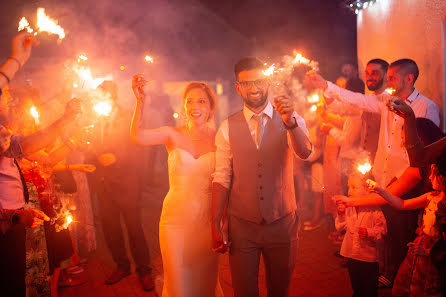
[131,74,223,297]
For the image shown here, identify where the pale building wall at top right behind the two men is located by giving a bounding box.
[357,0,446,121]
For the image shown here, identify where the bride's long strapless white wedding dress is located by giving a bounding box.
[159,148,223,297]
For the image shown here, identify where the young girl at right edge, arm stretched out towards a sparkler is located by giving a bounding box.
[369,154,446,296]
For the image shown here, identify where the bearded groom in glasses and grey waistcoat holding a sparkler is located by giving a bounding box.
[212,57,312,297]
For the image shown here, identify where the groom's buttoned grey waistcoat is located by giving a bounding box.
[228,110,296,223]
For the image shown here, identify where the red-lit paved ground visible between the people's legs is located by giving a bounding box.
[59,193,390,297]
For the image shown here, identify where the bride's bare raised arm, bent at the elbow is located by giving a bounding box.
[130,74,173,145]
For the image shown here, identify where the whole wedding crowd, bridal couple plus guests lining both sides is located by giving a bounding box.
[0,32,446,297]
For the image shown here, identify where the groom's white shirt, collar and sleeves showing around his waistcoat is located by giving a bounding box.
[213,101,308,189]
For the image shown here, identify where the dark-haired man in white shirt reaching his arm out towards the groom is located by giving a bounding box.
[306,59,440,186]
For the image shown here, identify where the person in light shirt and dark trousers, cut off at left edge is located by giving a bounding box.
[0,98,80,296]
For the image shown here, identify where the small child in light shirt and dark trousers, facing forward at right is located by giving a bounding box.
[335,174,387,297]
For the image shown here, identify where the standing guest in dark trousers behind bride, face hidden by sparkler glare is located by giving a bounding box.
[88,81,155,291]
